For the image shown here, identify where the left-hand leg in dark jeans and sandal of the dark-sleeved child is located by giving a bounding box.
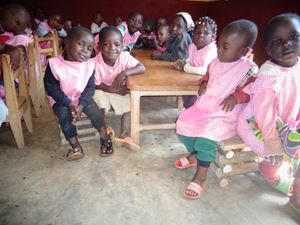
[52,104,84,160]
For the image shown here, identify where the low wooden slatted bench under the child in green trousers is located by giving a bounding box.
[211,136,259,187]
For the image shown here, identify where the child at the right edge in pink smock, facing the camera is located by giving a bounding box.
[238,13,300,209]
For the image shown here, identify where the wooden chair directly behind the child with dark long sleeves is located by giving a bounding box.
[28,33,59,112]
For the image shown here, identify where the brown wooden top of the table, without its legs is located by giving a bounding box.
[127,49,201,91]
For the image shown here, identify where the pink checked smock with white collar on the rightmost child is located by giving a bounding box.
[238,58,300,157]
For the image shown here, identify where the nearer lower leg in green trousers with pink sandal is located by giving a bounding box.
[184,138,218,198]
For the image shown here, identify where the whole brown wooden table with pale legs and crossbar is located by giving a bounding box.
[127,50,200,145]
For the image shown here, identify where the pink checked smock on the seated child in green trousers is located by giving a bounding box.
[176,57,256,141]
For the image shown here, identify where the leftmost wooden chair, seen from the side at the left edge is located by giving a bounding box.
[1,51,33,148]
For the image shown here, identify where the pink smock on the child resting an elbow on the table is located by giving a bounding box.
[94,52,139,86]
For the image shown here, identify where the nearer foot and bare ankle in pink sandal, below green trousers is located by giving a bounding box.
[183,166,208,199]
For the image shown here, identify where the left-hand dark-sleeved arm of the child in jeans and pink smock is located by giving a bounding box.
[44,64,72,107]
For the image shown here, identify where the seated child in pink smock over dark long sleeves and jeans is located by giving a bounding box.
[44,27,113,160]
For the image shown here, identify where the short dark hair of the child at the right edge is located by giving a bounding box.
[263,13,300,47]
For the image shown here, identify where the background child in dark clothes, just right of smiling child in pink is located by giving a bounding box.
[134,18,155,48]
